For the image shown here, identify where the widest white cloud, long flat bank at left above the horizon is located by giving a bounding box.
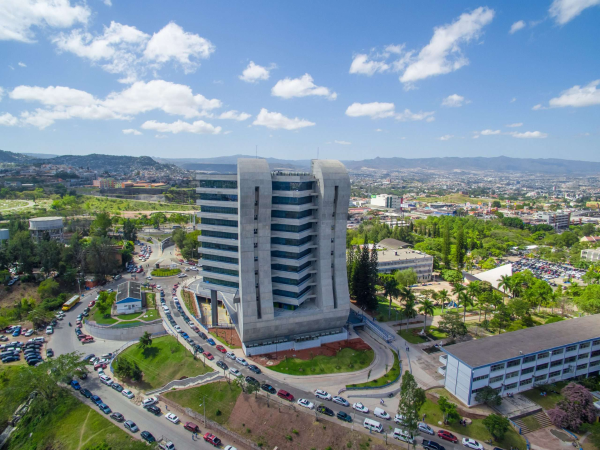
[9,80,225,128]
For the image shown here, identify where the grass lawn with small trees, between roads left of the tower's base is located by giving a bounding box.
[119,336,212,390]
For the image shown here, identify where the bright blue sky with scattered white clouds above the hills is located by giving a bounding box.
[0,0,600,161]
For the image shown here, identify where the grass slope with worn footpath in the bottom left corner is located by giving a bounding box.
[8,392,147,450]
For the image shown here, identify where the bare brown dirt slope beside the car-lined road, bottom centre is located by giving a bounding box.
[227,394,390,450]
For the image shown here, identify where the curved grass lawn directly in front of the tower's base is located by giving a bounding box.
[269,348,375,375]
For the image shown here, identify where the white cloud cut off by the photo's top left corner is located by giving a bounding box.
[0,0,91,43]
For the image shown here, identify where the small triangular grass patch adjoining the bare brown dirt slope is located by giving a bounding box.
[163,381,242,425]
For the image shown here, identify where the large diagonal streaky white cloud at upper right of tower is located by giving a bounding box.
[400,7,494,83]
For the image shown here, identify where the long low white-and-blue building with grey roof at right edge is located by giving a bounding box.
[438,314,600,406]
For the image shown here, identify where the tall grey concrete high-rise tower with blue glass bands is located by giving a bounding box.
[196,159,350,355]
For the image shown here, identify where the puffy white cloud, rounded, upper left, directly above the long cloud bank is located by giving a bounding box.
[144,22,215,73]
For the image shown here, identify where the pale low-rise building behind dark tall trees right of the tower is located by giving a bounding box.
[377,239,433,282]
